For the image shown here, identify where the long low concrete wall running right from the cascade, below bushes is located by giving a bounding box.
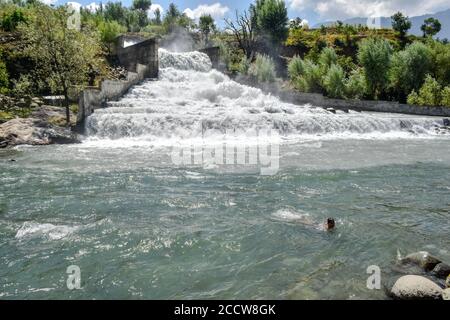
[236,77,450,117]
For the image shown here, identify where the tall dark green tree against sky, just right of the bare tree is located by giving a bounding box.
[253,0,289,46]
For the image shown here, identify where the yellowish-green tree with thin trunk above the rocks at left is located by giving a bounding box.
[21,5,101,125]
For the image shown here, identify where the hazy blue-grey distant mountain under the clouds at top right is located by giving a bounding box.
[313,9,450,40]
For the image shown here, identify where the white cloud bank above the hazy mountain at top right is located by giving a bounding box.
[289,0,450,20]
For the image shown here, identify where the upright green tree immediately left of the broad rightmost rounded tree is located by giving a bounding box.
[358,38,392,98]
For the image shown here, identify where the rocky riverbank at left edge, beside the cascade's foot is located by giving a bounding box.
[0,105,78,148]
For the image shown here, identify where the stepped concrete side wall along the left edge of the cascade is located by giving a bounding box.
[77,64,150,124]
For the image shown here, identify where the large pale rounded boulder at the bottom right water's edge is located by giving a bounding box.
[391,275,443,300]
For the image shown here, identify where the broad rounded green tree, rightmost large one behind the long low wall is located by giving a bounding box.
[391,42,432,99]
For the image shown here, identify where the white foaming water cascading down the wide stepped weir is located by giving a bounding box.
[86,49,442,146]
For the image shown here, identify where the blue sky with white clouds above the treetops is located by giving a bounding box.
[41,0,450,26]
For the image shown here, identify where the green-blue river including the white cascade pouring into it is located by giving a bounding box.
[0,50,450,299]
